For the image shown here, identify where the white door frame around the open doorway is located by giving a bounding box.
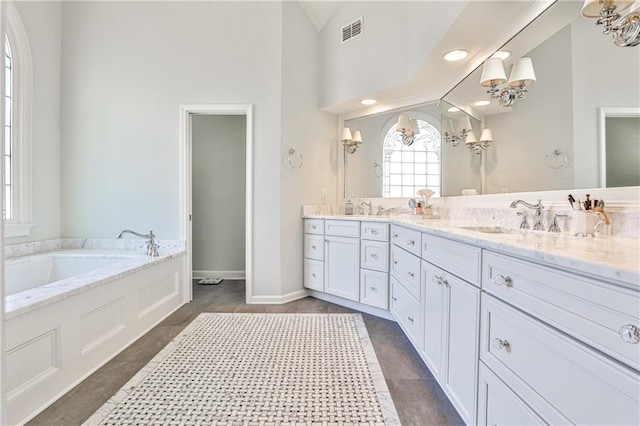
[180,104,253,303]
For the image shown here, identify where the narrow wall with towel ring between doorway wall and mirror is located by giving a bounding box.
[282,2,338,295]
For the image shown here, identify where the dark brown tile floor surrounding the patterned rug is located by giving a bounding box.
[28,280,464,426]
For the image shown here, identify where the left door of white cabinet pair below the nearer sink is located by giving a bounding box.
[422,261,447,377]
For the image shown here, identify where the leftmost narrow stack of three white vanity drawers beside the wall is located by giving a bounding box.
[303,219,324,291]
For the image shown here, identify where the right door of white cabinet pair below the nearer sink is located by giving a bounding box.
[443,277,480,424]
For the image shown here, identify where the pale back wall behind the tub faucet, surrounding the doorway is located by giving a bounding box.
[61,2,284,295]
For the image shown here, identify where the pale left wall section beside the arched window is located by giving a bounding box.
[6,1,62,244]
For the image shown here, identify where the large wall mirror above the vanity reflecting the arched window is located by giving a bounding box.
[344,2,640,197]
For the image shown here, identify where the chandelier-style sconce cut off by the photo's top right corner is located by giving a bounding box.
[582,0,640,47]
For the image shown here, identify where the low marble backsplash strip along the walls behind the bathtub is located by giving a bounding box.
[4,238,185,259]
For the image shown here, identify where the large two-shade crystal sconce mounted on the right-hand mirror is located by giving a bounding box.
[480,57,536,107]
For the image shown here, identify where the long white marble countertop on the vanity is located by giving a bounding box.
[303,215,640,289]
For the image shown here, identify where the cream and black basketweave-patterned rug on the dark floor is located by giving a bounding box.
[85,313,400,425]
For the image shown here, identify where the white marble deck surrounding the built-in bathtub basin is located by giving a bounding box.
[4,247,185,319]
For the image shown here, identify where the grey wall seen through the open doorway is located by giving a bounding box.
[191,115,246,278]
